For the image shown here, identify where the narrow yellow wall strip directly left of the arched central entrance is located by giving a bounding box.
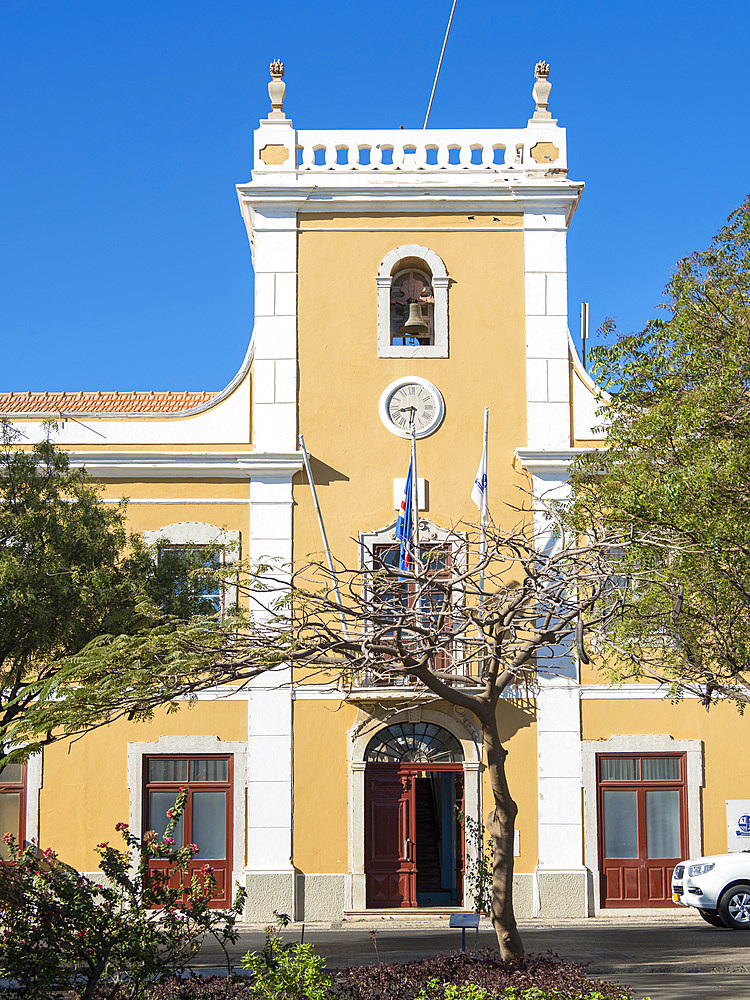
[293,701,357,875]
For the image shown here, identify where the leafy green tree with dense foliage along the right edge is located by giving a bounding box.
[572,198,750,705]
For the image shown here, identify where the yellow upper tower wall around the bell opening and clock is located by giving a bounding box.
[294,215,526,561]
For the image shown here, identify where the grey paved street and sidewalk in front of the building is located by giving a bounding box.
[195,911,750,1000]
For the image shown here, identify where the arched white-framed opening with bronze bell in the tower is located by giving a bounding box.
[376,244,449,358]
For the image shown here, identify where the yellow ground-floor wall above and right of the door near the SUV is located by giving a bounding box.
[581,699,750,854]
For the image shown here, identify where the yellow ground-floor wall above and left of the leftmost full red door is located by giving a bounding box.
[39,701,247,871]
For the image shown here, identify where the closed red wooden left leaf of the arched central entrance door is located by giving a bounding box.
[365,764,417,907]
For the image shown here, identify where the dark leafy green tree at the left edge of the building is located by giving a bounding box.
[0,423,238,763]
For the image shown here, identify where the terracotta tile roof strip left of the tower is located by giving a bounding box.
[0,392,218,417]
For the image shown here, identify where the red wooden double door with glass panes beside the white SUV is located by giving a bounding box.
[599,755,687,907]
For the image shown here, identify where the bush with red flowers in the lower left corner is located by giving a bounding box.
[0,789,245,1000]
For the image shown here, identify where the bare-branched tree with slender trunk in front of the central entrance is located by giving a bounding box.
[270,527,627,957]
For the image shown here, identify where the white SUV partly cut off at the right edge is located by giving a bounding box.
[672,851,750,931]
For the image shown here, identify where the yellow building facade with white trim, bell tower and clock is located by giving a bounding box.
[0,64,728,921]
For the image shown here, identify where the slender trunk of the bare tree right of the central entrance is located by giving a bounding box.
[482,713,523,959]
